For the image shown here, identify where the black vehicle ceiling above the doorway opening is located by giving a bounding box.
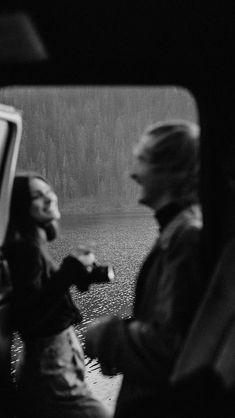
[0,0,235,85]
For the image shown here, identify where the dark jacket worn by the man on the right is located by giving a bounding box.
[86,205,203,417]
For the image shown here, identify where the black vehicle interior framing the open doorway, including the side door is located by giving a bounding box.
[0,0,235,417]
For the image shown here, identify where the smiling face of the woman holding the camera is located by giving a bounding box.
[29,177,60,226]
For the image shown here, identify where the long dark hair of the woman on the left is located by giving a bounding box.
[5,172,48,243]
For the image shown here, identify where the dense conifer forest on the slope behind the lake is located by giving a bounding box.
[0,87,197,212]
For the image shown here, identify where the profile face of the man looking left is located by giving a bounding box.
[131,136,169,210]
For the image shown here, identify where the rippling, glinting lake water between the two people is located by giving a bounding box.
[11,213,157,409]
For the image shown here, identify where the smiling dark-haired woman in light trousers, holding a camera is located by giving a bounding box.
[4,173,109,418]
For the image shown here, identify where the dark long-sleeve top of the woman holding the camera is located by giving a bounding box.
[4,240,89,339]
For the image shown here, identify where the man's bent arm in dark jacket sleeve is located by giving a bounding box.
[86,225,203,381]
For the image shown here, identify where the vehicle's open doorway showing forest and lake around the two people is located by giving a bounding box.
[0,86,198,412]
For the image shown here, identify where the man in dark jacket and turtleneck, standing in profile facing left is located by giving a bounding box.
[86,120,203,418]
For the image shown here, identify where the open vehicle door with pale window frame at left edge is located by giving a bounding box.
[0,104,22,418]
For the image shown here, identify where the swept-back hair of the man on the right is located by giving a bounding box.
[135,120,200,205]
